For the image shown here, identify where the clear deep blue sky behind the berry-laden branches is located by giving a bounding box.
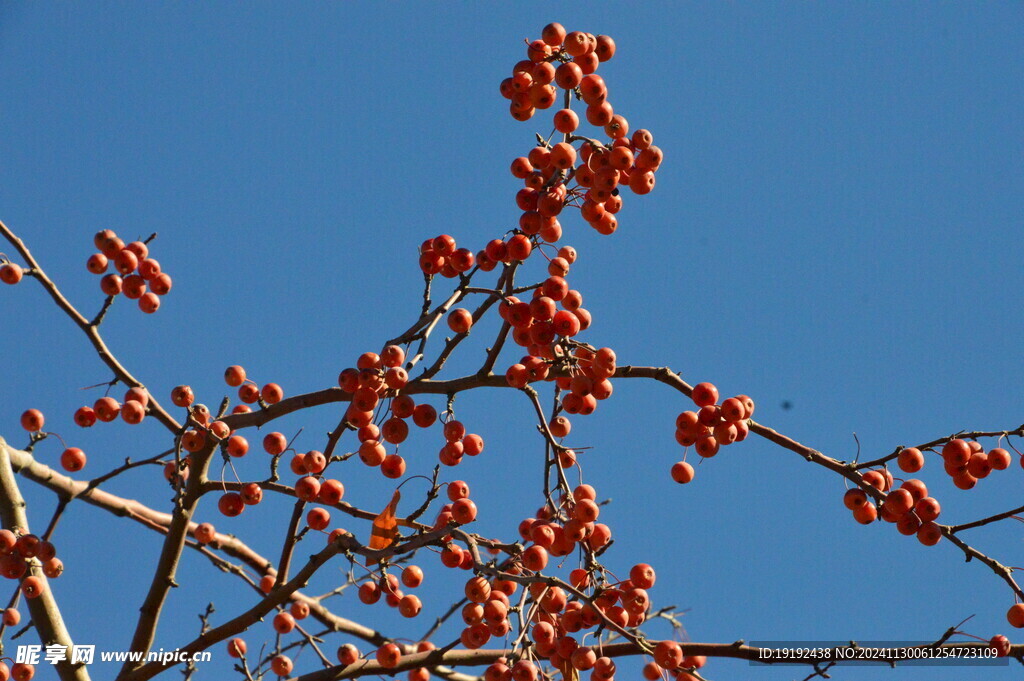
[0,2,1024,681]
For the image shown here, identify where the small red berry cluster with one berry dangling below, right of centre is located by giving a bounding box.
[672,383,754,483]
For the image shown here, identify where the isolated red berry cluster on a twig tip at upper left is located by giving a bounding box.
[85,229,171,314]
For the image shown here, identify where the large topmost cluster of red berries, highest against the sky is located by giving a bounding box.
[500,24,664,237]
